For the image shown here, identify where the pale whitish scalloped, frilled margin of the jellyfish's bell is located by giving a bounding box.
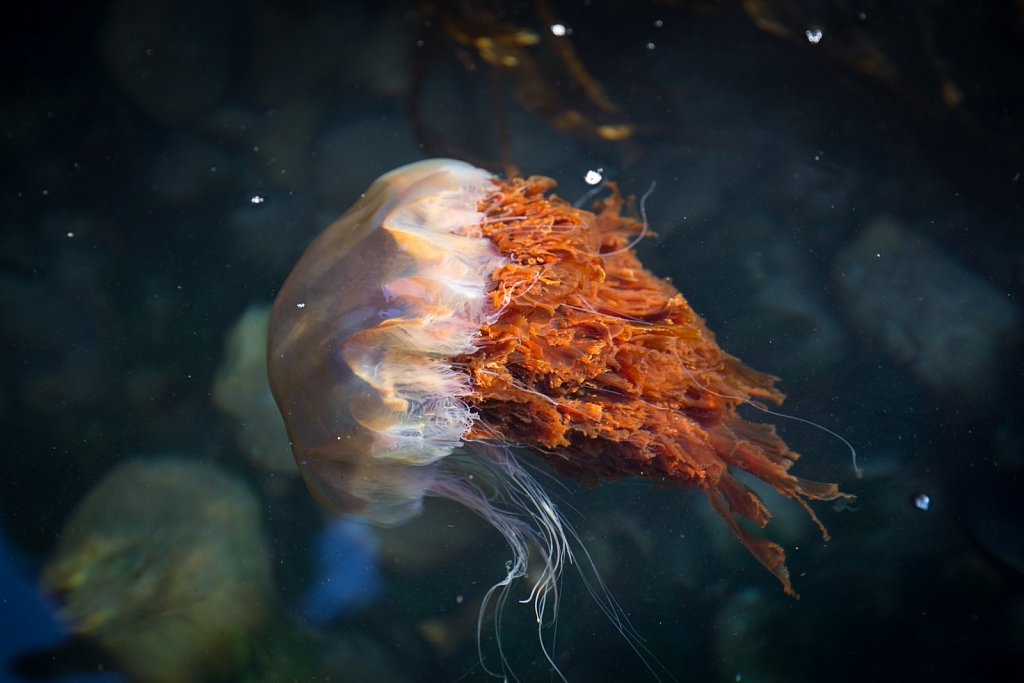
[342,162,507,465]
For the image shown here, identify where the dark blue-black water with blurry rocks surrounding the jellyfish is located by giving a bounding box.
[0,0,1024,681]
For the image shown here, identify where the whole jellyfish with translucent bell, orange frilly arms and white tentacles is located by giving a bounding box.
[267,159,845,661]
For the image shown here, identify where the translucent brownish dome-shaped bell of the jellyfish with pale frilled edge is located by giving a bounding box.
[267,161,505,524]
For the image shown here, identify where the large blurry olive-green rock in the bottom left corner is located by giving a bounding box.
[43,458,270,683]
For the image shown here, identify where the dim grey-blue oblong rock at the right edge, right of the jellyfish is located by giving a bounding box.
[833,219,1020,401]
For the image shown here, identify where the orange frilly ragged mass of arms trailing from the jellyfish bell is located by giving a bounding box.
[458,177,844,595]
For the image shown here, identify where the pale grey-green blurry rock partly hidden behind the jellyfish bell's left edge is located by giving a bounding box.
[213,304,297,474]
